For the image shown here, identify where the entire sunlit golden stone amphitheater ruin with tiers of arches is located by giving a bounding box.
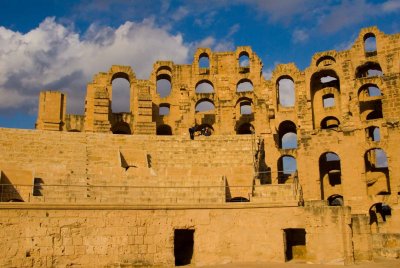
[0,27,400,267]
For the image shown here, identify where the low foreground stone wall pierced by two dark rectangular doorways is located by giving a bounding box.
[0,204,353,267]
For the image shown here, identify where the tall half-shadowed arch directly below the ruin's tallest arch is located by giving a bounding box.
[319,152,342,200]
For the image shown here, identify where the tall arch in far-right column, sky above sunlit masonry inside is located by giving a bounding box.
[364,148,390,195]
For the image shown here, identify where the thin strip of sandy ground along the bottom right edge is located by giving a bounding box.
[203,258,400,268]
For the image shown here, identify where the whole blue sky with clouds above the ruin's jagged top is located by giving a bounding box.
[0,0,400,128]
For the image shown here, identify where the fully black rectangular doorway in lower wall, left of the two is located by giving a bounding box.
[174,229,194,266]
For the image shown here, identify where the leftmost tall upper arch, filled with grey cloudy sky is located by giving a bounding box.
[111,74,131,113]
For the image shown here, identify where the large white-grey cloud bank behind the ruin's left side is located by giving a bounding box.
[0,18,189,112]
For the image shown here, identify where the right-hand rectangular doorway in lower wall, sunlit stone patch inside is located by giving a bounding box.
[284,228,307,261]
